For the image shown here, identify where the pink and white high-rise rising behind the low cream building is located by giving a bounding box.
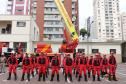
[7,0,32,15]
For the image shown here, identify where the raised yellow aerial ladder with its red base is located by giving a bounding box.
[54,0,79,53]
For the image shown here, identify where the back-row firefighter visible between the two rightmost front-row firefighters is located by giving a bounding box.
[101,55,108,77]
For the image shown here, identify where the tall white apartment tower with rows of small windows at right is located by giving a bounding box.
[93,0,122,41]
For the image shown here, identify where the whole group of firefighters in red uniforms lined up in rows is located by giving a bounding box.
[7,52,117,81]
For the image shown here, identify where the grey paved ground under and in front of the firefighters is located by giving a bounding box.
[0,64,126,84]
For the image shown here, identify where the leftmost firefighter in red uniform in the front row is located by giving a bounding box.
[7,54,18,80]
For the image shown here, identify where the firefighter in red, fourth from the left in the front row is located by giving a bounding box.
[50,54,60,81]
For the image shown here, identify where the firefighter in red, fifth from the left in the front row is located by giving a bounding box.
[64,54,73,81]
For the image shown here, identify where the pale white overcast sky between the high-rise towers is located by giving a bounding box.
[79,0,126,28]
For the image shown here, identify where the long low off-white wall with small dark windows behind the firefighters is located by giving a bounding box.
[48,42,122,63]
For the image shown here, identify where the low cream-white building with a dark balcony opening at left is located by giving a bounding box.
[0,15,39,52]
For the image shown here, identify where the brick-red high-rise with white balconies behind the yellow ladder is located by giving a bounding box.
[36,0,79,41]
